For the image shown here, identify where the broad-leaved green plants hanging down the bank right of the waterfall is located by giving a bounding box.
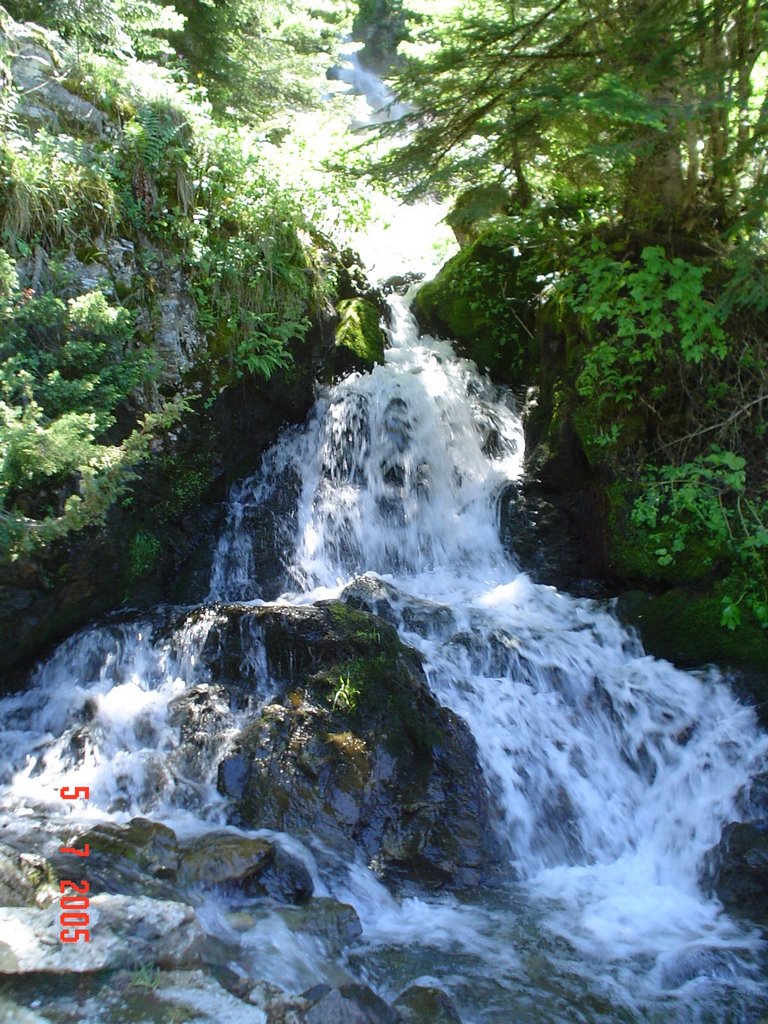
[558,241,768,629]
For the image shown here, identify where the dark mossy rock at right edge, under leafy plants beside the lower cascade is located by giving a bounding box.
[616,587,768,679]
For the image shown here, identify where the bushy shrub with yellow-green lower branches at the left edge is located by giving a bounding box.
[0,264,166,556]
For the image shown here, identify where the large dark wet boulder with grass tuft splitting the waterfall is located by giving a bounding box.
[219,602,500,886]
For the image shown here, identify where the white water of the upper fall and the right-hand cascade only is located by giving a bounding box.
[208,301,768,1019]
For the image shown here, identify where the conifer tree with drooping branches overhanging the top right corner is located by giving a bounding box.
[379,0,768,227]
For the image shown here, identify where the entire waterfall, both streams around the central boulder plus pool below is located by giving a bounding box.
[1,278,768,1024]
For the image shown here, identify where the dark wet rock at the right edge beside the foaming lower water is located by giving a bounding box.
[710,820,768,922]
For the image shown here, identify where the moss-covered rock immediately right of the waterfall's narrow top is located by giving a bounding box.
[414,222,539,385]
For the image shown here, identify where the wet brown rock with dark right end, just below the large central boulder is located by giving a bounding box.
[179,833,313,903]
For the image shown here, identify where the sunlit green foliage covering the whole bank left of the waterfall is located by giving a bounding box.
[0,0,358,571]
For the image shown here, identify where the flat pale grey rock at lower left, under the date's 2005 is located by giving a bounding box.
[0,893,204,974]
